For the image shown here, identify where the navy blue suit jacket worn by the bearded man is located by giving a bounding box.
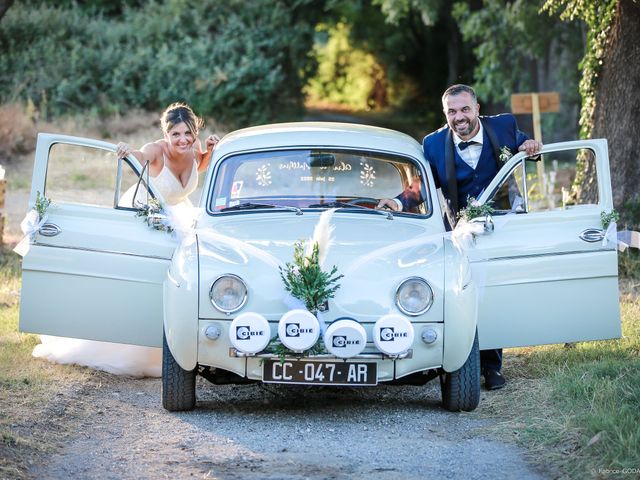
[422,113,529,213]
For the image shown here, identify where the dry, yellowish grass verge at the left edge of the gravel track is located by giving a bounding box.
[0,246,88,479]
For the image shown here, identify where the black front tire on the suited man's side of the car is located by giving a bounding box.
[440,330,480,412]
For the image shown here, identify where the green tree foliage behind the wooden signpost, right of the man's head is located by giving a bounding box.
[453,0,585,143]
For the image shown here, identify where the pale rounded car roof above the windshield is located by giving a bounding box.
[216,122,423,161]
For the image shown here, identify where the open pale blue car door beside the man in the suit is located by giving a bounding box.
[468,140,620,349]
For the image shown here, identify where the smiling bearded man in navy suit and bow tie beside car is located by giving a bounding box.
[378,84,542,390]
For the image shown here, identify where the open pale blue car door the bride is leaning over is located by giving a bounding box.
[20,134,176,346]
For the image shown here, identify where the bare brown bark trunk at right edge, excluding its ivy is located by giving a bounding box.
[591,0,640,226]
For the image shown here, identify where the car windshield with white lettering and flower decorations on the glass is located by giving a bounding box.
[209,149,430,215]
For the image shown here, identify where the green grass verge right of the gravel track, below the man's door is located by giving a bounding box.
[481,282,640,478]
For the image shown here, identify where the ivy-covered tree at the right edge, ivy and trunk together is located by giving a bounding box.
[545,0,640,227]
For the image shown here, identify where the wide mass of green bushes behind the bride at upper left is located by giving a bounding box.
[0,0,320,126]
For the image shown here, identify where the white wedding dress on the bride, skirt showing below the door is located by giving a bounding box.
[32,158,198,377]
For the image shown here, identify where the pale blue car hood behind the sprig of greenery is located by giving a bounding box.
[196,211,444,321]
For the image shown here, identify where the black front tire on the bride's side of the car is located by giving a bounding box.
[162,332,196,412]
